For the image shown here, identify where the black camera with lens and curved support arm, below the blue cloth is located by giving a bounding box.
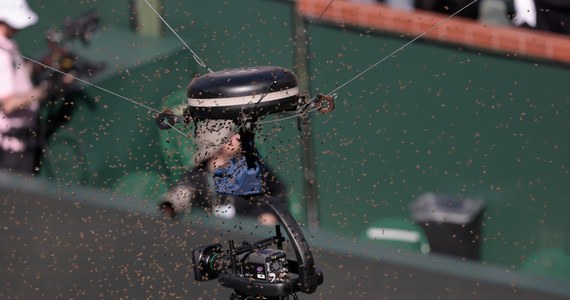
[192,196,323,299]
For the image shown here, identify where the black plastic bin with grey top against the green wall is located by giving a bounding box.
[411,193,484,260]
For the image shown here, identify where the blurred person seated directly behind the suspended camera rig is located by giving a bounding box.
[159,120,286,225]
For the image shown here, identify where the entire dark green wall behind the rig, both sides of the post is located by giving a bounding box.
[19,0,570,282]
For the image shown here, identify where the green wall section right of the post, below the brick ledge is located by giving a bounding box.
[309,25,570,266]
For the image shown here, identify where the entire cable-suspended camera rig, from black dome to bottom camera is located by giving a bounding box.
[155,66,334,299]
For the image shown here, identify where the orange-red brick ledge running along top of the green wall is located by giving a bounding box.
[297,0,570,64]
